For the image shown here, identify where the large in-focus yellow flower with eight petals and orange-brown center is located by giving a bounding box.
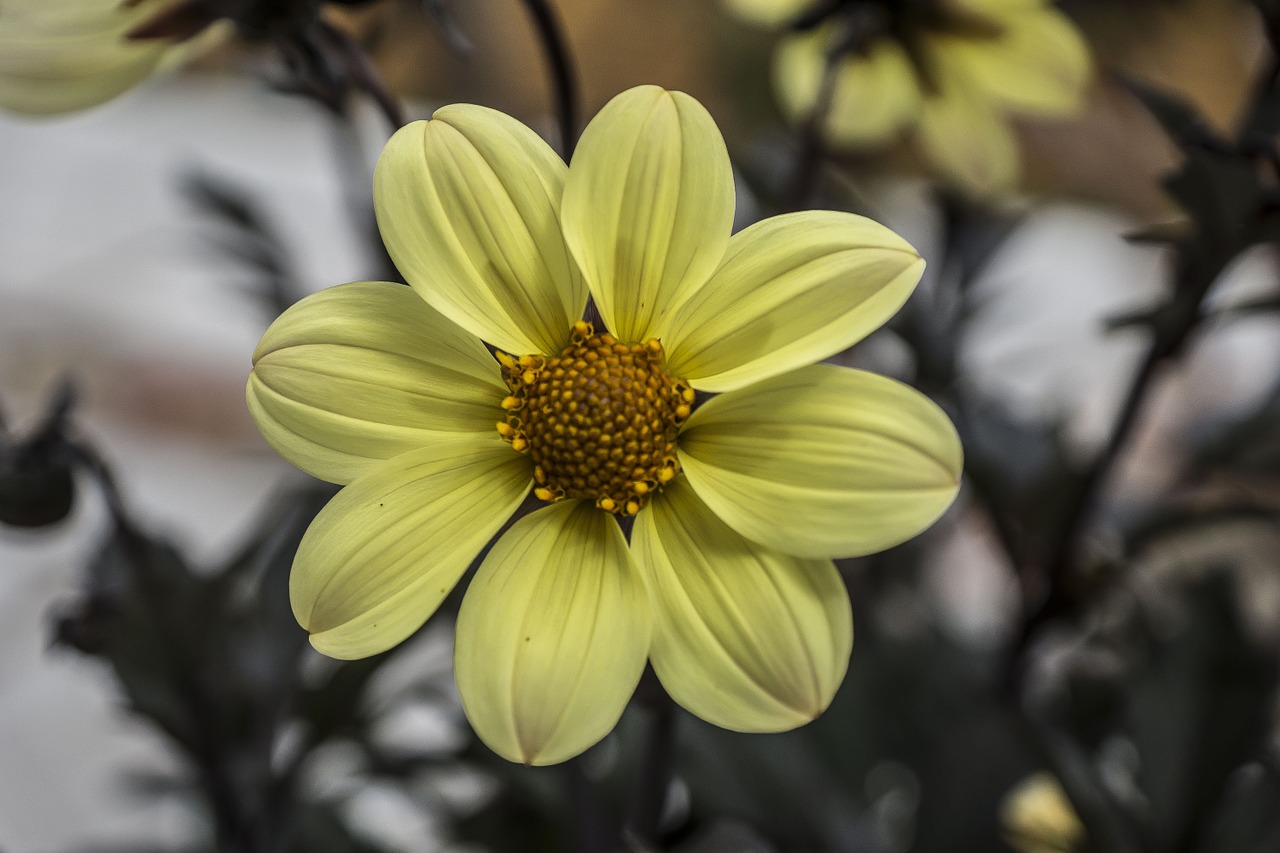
[247,86,961,765]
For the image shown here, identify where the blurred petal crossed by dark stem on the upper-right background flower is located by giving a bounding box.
[773,27,920,147]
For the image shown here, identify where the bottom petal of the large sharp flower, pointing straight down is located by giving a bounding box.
[454,501,653,765]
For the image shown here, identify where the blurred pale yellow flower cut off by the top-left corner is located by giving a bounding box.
[0,0,195,114]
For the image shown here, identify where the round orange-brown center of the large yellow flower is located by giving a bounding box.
[498,321,694,515]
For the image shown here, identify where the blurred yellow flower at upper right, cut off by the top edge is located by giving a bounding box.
[726,0,1091,196]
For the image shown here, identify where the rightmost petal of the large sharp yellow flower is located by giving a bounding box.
[680,365,963,557]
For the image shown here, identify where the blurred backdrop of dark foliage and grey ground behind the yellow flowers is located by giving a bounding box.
[0,0,1280,853]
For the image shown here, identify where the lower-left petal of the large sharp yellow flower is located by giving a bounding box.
[289,434,532,660]
